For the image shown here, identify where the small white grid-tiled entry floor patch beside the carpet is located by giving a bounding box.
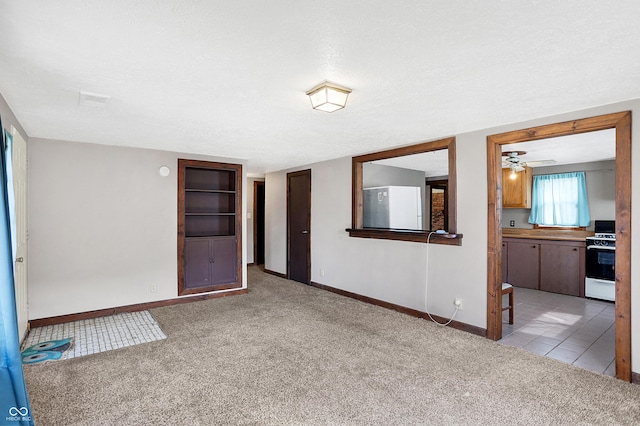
[22,311,167,359]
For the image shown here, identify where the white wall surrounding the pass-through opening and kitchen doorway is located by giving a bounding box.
[265,100,640,372]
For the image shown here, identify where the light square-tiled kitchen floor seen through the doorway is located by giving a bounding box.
[500,287,615,376]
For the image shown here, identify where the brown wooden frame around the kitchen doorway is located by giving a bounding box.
[487,111,632,382]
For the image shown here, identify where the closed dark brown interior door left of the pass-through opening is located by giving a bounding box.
[287,170,311,284]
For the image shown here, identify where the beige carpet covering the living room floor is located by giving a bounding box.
[25,267,640,426]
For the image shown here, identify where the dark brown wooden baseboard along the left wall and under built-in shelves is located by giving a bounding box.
[30,288,249,328]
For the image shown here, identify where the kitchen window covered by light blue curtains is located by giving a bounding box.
[529,172,591,227]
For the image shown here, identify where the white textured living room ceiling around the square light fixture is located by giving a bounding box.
[0,0,640,174]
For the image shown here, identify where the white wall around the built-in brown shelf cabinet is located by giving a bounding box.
[29,138,246,319]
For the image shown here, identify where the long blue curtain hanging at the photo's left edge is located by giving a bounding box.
[0,122,33,426]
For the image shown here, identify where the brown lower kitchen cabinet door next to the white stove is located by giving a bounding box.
[540,243,582,296]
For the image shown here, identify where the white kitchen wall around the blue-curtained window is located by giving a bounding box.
[502,160,616,231]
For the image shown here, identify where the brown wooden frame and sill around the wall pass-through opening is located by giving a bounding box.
[347,137,462,245]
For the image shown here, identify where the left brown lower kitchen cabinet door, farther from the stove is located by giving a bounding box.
[507,241,540,290]
